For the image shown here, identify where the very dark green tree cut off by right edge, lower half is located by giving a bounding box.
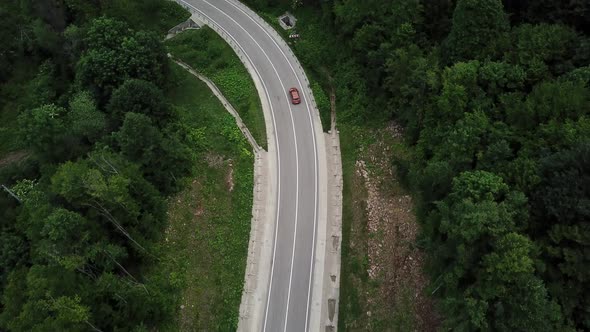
[531,142,590,328]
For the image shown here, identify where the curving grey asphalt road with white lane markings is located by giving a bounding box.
[177,0,321,332]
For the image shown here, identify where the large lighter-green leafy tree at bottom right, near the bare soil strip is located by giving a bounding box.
[430,171,562,331]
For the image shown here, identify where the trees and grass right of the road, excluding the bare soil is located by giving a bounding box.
[246,0,590,331]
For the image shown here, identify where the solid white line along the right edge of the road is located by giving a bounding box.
[226,0,318,330]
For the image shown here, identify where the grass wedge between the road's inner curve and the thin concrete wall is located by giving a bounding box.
[166,27,267,149]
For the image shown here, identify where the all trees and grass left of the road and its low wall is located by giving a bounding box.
[0,0,253,332]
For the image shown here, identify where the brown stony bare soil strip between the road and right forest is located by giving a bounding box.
[351,123,440,332]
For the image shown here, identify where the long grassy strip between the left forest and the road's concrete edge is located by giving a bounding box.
[148,64,254,331]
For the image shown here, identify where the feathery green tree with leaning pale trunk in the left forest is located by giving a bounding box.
[51,150,164,249]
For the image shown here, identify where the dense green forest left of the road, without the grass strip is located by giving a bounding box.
[0,0,196,331]
